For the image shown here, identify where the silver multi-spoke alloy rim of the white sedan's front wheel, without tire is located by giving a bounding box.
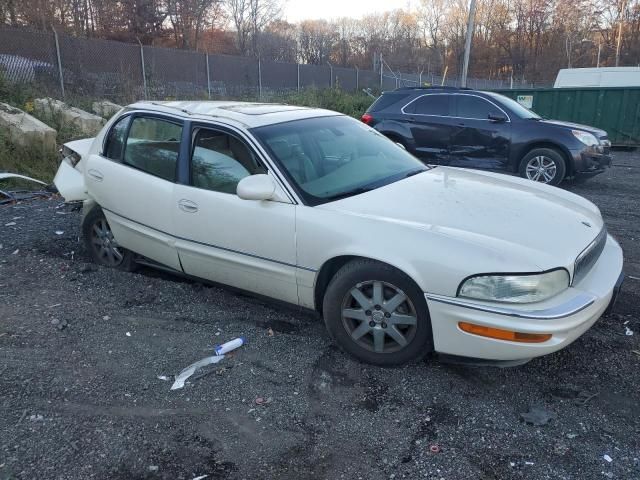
[342,280,418,353]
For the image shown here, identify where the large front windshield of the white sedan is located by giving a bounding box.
[252,116,428,205]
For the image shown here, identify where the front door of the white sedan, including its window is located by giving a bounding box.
[170,125,298,303]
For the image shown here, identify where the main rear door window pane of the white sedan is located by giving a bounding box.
[123,117,182,182]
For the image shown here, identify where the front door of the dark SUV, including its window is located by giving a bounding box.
[449,93,511,170]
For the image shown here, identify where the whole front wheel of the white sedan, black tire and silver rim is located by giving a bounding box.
[323,259,433,366]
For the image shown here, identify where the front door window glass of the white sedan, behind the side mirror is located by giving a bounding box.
[191,129,266,194]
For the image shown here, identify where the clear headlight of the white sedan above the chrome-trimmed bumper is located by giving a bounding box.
[458,269,569,303]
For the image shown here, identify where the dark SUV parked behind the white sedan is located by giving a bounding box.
[362,87,611,185]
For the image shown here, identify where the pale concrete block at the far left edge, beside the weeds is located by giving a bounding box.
[0,103,56,152]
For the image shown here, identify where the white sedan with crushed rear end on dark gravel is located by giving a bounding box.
[55,102,623,365]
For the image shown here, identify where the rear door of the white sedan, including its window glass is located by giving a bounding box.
[85,113,183,270]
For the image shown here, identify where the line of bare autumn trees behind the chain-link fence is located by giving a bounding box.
[0,0,640,83]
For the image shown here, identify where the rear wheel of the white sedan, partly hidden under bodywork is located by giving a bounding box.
[82,206,137,272]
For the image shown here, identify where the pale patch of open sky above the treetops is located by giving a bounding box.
[283,0,416,22]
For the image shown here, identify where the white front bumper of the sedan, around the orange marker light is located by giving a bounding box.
[425,232,623,360]
